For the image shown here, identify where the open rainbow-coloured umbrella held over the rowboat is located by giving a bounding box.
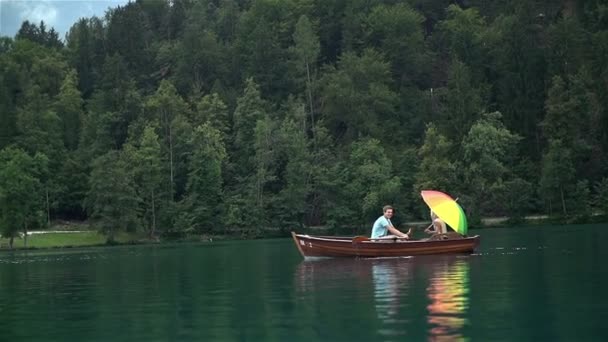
[420,190,467,235]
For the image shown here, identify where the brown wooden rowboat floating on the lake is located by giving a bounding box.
[291,232,481,258]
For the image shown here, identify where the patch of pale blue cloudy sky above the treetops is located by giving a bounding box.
[0,0,129,39]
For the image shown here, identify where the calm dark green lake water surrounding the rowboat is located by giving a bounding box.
[0,225,608,341]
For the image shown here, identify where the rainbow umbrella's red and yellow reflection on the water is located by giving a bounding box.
[427,259,469,341]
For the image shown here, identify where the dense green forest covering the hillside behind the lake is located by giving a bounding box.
[0,0,608,241]
